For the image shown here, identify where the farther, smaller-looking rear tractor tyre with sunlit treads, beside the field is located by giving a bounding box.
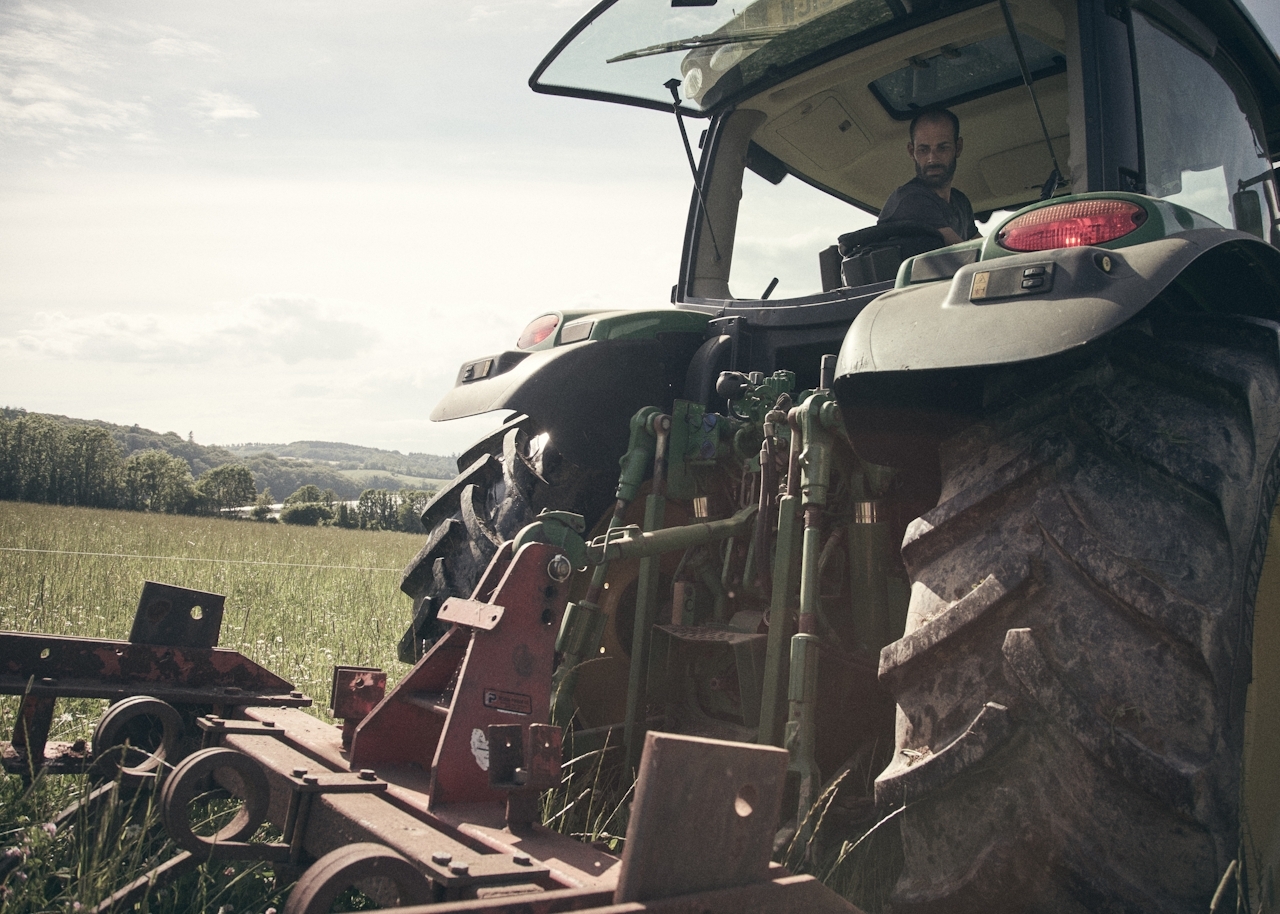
[397,416,616,663]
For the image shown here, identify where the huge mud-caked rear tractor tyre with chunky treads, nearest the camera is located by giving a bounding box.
[877,316,1280,914]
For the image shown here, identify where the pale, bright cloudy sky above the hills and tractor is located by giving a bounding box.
[0,0,1280,453]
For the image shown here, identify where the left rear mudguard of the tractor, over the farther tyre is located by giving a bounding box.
[431,309,708,467]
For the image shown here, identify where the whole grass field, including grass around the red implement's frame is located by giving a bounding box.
[0,502,421,914]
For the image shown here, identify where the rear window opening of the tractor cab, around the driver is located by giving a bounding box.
[711,0,1084,301]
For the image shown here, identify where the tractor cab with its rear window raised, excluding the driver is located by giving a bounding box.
[530,0,1280,317]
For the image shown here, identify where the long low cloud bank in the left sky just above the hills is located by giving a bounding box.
[0,296,380,365]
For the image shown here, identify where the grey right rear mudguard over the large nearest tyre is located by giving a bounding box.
[835,227,1280,466]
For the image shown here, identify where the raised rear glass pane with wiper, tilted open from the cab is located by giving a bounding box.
[530,0,973,114]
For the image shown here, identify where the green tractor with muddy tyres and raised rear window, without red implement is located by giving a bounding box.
[401,0,1280,914]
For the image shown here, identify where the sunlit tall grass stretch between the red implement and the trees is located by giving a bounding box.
[0,502,421,704]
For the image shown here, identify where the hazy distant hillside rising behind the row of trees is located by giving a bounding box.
[0,407,457,499]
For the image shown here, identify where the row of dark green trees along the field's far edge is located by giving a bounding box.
[0,412,431,533]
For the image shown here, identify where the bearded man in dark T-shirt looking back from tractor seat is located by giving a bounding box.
[879,108,978,245]
